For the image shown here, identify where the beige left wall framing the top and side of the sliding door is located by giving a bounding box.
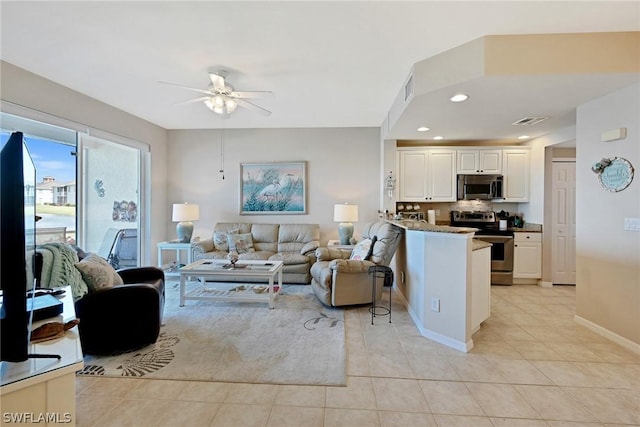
[0,61,170,264]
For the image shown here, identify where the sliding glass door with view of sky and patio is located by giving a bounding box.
[0,112,150,267]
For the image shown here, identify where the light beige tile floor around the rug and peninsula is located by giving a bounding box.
[76,285,640,427]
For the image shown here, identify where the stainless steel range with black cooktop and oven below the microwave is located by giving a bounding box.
[451,211,514,285]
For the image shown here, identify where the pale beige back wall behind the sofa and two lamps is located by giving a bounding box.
[168,128,382,243]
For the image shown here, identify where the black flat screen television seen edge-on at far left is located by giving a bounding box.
[0,132,36,362]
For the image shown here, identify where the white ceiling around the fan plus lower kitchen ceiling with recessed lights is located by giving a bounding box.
[0,1,640,140]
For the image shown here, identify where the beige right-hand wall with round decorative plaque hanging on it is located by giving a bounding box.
[576,84,640,345]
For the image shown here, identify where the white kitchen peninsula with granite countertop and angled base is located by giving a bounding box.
[387,220,491,352]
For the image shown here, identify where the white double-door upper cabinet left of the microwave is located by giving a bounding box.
[398,149,456,202]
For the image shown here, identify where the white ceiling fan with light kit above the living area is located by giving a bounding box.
[159,70,271,117]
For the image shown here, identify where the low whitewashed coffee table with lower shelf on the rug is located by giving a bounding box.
[179,259,283,308]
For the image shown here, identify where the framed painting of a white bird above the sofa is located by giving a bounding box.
[240,161,307,215]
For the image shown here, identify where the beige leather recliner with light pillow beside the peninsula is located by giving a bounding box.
[311,222,404,306]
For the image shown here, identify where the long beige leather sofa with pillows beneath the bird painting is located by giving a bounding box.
[192,222,320,284]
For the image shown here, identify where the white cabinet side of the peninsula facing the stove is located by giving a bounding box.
[471,246,491,333]
